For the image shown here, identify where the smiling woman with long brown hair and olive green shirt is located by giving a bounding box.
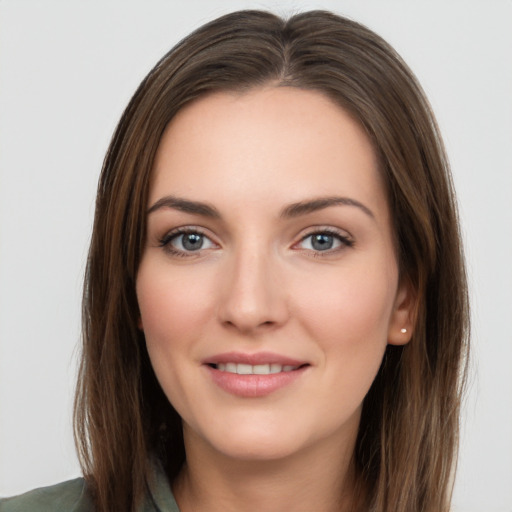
[0,11,468,512]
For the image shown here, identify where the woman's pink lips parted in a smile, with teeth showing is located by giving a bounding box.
[203,352,310,398]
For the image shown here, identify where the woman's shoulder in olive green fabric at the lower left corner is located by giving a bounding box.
[0,478,93,512]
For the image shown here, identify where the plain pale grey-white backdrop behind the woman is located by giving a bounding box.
[0,0,512,512]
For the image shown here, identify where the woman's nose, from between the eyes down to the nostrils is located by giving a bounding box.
[219,248,289,335]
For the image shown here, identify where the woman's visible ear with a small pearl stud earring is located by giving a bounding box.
[388,279,418,345]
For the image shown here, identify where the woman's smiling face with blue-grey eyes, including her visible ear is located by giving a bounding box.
[137,87,410,459]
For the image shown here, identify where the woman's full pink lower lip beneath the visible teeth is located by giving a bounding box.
[205,366,308,398]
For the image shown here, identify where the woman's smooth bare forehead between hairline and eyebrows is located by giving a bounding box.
[150,87,385,218]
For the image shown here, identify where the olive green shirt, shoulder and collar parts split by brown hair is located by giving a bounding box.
[0,465,179,512]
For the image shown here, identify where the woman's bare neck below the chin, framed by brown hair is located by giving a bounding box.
[173,428,355,512]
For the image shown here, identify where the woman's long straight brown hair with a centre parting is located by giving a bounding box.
[74,11,468,512]
